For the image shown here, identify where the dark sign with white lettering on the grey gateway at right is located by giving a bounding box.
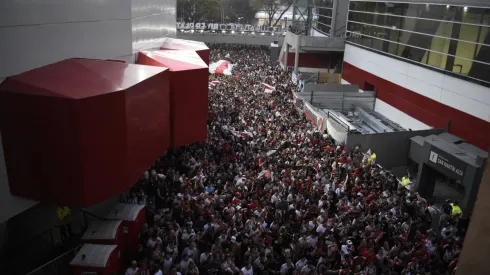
[428,147,466,180]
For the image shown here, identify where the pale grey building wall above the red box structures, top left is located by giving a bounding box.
[0,0,176,78]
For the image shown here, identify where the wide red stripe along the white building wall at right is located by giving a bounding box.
[342,61,490,151]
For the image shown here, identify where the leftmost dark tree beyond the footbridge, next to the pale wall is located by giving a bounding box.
[177,0,222,23]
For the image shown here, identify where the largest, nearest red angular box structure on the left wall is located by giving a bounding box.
[0,59,170,207]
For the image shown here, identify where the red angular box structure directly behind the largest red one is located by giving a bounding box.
[136,50,209,147]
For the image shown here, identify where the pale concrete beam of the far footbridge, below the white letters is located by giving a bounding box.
[177,32,284,46]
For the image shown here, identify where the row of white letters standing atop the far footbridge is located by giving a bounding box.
[177,22,281,32]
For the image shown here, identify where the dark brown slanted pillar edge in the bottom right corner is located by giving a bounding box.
[456,155,490,275]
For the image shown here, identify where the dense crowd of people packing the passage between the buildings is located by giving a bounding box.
[121,44,464,275]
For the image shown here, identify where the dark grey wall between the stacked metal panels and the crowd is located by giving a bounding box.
[346,129,445,169]
